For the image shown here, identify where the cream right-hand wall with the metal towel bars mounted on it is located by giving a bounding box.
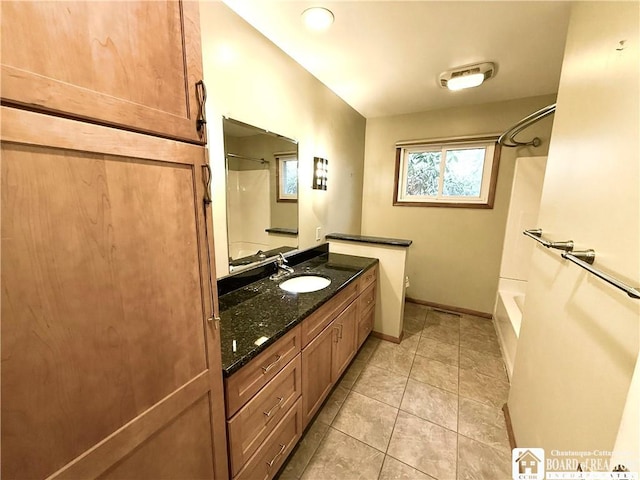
[509,2,640,458]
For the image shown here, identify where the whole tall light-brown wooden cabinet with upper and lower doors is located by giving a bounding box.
[0,2,228,479]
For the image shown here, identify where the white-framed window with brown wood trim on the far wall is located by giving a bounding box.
[393,138,500,208]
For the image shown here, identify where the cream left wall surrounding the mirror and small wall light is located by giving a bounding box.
[200,1,365,276]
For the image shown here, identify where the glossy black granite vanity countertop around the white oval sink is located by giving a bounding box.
[219,253,378,377]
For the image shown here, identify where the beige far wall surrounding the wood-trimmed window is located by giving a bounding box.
[362,95,555,313]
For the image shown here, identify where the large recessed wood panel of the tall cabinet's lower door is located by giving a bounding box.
[2,146,206,473]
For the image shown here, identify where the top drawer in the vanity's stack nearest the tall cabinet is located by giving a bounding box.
[225,325,300,418]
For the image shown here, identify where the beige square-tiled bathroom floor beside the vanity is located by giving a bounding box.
[279,303,511,480]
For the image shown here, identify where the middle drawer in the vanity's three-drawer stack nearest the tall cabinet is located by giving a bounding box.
[228,355,302,476]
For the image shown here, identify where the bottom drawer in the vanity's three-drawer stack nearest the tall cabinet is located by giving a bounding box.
[234,399,302,480]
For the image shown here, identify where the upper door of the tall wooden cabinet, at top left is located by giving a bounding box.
[0,0,204,143]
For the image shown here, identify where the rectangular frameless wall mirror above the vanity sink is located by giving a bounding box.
[223,118,298,273]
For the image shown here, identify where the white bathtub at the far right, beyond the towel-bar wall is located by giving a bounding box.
[493,282,526,379]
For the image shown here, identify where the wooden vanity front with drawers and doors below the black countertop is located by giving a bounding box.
[225,267,377,480]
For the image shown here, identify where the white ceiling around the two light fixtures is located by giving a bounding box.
[224,0,570,118]
